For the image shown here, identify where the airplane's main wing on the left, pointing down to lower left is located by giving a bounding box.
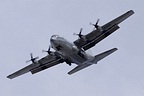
[7,55,62,79]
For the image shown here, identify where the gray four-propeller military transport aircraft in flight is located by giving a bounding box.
[7,10,134,79]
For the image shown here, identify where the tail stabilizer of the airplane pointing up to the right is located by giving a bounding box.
[94,48,118,63]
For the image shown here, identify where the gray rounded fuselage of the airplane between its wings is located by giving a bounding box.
[50,35,92,65]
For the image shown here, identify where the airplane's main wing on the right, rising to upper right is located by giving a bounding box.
[74,10,134,50]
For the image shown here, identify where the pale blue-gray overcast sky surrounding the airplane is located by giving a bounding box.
[0,0,144,96]
